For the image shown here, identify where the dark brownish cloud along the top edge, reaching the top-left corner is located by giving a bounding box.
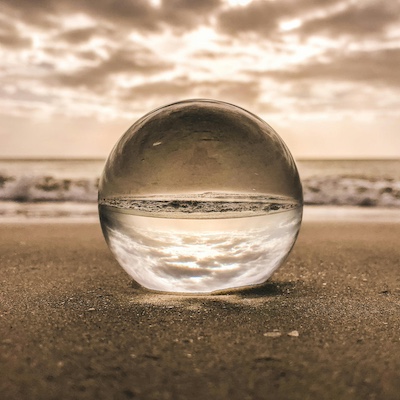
[2,0,221,31]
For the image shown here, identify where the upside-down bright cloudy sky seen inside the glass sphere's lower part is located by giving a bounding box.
[101,207,301,293]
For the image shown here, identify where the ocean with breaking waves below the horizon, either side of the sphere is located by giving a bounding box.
[0,159,400,219]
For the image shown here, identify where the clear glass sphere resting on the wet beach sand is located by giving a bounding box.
[99,100,303,293]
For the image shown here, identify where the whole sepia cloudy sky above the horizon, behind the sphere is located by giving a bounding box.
[0,0,400,159]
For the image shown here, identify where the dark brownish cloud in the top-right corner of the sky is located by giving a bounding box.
[218,0,400,41]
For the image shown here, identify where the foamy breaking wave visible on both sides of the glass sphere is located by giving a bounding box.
[0,173,400,207]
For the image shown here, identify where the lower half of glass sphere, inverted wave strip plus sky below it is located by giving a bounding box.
[99,194,302,292]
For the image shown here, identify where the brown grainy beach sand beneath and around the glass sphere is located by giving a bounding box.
[0,220,400,400]
